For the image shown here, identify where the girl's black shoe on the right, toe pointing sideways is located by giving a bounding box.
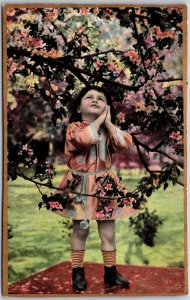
[104,266,130,288]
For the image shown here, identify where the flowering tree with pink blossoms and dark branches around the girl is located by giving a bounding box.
[7,7,183,244]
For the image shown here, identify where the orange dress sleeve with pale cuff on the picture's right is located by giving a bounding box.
[110,126,133,153]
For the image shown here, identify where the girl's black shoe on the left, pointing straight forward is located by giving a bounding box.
[72,267,87,291]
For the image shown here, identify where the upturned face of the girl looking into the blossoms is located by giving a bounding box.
[78,90,107,121]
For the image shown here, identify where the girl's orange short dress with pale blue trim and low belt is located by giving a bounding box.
[52,121,137,224]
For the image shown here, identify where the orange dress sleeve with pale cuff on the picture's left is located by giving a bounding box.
[65,122,102,152]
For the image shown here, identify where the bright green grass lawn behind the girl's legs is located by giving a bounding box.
[8,166,184,283]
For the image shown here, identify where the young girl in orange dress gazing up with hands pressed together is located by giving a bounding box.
[52,86,136,291]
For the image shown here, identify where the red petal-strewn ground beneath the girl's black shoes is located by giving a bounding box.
[9,262,187,296]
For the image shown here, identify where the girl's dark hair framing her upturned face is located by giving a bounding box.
[69,86,116,124]
